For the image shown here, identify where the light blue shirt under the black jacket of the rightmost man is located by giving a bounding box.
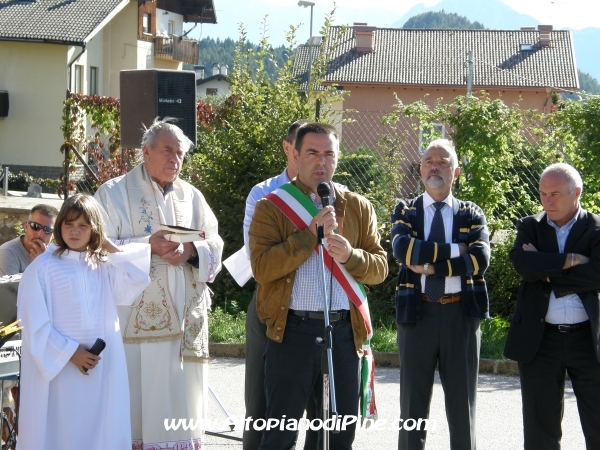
[546,208,589,325]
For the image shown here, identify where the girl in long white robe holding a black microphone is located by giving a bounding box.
[17,194,150,450]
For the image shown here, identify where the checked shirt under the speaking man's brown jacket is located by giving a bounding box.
[290,185,350,311]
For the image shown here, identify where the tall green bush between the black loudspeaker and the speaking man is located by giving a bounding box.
[184,13,342,311]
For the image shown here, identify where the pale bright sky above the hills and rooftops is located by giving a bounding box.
[186,0,600,46]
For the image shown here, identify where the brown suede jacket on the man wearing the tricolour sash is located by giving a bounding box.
[249,178,388,356]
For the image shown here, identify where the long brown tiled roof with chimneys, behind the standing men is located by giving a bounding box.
[294,27,579,89]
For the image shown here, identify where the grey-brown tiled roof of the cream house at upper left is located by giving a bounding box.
[0,0,129,45]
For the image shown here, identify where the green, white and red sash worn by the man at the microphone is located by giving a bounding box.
[265,183,377,419]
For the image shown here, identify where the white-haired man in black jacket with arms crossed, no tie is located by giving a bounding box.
[504,163,600,450]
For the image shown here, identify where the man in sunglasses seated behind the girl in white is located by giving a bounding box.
[0,205,58,276]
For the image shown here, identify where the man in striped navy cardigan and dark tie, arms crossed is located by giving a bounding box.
[392,139,490,450]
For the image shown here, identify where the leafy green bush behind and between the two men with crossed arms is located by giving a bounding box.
[386,92,554,232]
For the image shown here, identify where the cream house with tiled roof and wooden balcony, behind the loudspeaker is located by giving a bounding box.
[0,0,216,178]
